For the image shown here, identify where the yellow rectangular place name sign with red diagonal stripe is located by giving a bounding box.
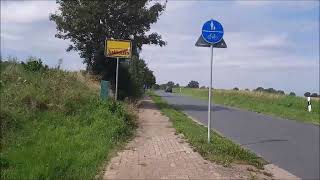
[105,39,131,58]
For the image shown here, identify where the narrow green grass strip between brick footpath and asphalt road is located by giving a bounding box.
[149,93,266,168]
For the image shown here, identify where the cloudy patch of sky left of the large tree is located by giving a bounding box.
[1,1,85,70]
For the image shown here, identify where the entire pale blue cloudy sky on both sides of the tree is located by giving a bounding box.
[1,0,319,95]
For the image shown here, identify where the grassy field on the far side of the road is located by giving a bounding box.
[173,88,320,125]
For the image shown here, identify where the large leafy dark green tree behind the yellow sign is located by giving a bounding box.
[50,0,166,98]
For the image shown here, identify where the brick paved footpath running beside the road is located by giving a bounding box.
[103,99,248,179]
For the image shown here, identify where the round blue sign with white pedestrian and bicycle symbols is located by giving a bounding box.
[202,19,223,44]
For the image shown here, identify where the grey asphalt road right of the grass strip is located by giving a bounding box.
[157,91,319,179]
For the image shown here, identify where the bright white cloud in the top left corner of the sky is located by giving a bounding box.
[1,1,57,23]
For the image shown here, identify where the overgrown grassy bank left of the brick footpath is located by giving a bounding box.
[0,62,135,179]
